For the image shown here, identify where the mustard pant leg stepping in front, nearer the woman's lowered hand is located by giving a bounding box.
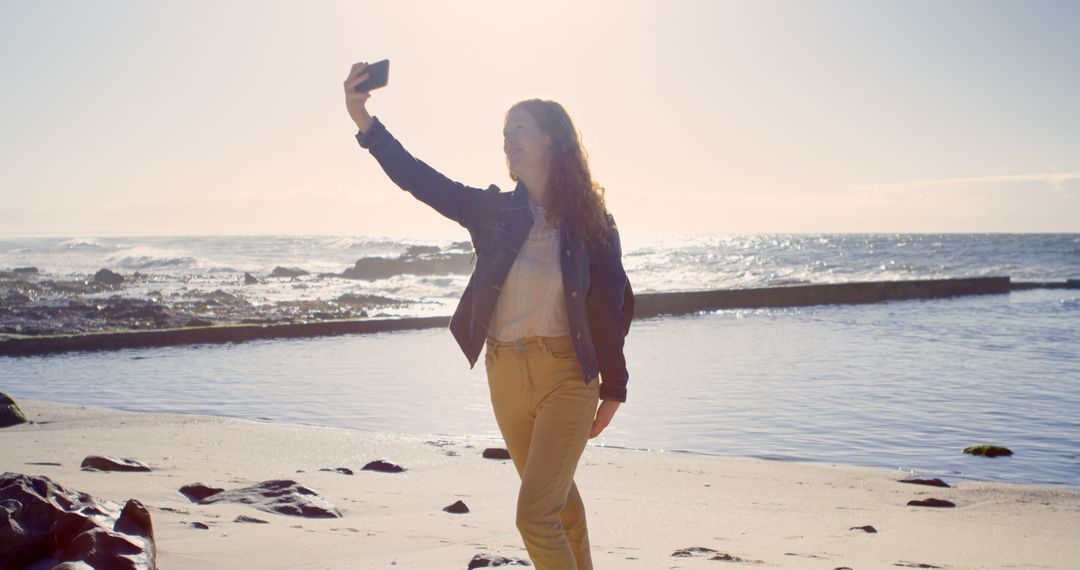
[517,340,599,570]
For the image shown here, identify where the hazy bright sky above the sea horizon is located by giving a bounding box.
[0,0,1080,239]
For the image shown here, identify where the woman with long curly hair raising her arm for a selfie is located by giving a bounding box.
[345,63,634,570]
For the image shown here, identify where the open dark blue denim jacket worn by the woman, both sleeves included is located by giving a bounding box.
[356,118,634,402]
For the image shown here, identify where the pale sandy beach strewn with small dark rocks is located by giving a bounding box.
[0,401,1080,570]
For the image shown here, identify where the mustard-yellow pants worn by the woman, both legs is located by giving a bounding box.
[484,336,599,570]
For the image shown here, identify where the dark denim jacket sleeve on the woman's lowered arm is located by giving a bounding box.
[588,215,633,402]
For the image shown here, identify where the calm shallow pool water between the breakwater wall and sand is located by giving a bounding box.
[0,289,1080,488]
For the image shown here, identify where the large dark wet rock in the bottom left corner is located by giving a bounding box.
[0,473,157,570]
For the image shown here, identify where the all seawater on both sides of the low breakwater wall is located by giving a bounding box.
[0,234,1080,488]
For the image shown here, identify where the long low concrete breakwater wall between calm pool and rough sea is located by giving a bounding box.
[0,276,1080,356]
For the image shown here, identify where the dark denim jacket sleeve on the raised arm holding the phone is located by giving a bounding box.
[356,117,499,231]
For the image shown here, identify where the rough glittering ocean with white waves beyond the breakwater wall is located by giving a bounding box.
[0,233,1080,316]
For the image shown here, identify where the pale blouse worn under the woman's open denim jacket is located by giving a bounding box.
[488,204,570,341]
